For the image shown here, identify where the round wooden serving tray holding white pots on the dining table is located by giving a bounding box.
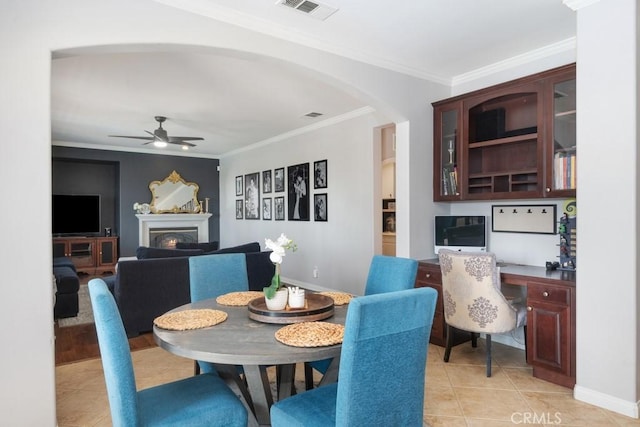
[247,292,333,324]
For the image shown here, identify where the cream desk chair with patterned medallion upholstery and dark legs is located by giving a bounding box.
[438,249,527,377]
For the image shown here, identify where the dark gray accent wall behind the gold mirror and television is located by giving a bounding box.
[52,146,220,256]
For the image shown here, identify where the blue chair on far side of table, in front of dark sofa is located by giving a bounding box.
[189,253,249,374]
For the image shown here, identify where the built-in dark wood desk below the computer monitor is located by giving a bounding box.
[416,259,576,388]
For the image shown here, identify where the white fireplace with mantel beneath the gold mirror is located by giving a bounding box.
[136,213,211,248]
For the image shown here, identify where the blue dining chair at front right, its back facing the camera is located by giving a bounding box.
[271,288,437,427]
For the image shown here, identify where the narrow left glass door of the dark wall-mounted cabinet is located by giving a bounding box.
[433,102,462,200]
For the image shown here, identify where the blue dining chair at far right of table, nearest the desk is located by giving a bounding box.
[304,255,418,390]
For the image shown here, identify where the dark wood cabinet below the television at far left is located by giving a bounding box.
[53,237,118,274]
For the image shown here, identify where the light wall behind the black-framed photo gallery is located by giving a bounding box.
[220,110,387,295]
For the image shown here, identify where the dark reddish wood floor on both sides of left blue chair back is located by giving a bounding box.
[54,323,156,365]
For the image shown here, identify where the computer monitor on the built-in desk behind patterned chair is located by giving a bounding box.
[434,215,487,254]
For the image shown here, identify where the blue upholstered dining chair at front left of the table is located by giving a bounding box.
[89,279,247,427]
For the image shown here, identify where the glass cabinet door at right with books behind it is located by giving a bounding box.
[546,71,577,197]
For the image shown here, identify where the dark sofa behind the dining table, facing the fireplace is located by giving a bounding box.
[108,242,275,337]
